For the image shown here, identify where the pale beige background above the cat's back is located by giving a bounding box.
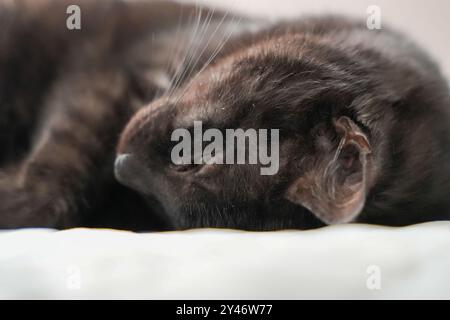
[181,0,450,78]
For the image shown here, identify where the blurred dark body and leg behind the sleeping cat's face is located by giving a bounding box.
[0,0,260,229]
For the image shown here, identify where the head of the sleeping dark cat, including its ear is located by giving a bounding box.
[115,40,373,230]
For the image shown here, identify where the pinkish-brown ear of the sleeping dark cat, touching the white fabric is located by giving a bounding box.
[286,117,371,224]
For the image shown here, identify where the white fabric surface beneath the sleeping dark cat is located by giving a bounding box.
[0,222,450,299]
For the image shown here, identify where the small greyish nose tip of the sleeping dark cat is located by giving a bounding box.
[114,153,145,191]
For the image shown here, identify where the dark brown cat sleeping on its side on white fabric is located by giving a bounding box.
[0,0,450,230]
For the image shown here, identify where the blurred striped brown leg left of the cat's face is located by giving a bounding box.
[0,70,131,228]
